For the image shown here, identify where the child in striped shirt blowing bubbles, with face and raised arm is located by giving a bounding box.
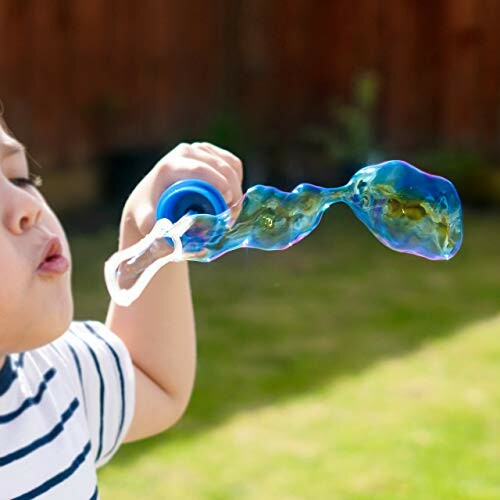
[0,114,243,500]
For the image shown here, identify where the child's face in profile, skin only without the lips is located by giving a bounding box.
[0,124,73,356]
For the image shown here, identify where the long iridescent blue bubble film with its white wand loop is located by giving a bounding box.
[105,160,463,305]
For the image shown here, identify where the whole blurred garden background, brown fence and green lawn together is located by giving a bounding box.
[0,0,500,499]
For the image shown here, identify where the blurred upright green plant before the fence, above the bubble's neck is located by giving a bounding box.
[304,71,383,181]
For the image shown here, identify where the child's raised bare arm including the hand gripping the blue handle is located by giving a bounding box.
[106,143,243,441]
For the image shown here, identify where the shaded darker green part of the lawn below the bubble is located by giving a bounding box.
[69,206,500,465]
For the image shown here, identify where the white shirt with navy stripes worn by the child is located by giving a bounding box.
[0,321,135,500]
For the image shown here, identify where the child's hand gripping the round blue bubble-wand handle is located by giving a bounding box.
[120,142,243,246]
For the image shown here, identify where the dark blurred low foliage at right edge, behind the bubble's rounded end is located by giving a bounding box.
[412,147,500,206]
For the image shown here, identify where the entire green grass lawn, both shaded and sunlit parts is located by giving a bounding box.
[68,206,500,500]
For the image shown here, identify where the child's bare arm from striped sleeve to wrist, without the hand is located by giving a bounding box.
[106,223,196,442]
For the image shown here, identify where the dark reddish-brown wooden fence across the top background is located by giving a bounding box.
[0,0,500,168]
